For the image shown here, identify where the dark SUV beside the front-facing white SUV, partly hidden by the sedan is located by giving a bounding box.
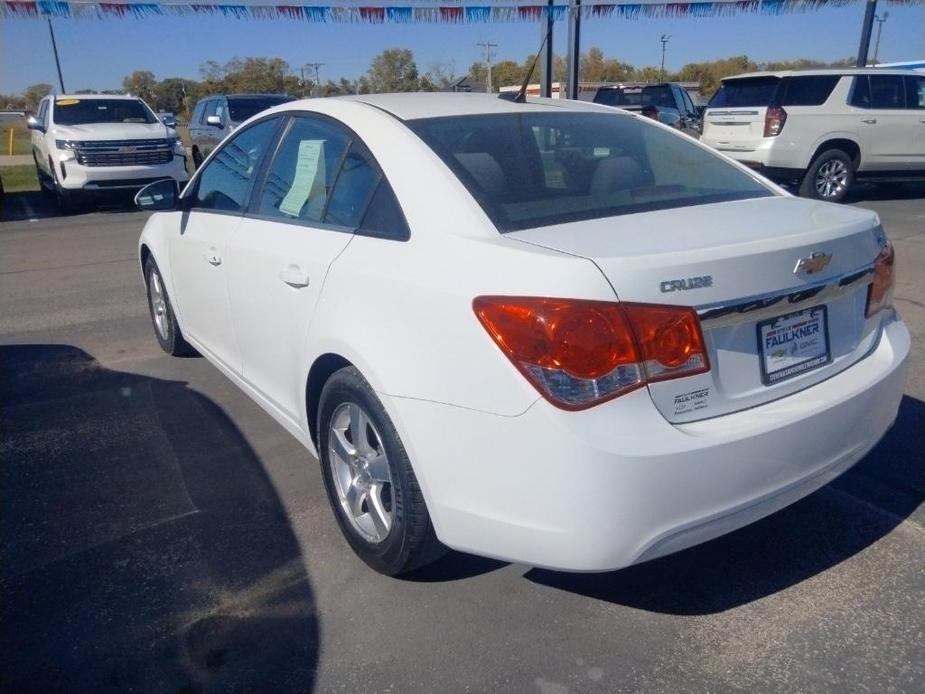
[189,94,293,169]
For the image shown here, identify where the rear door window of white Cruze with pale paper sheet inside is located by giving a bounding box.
[257,117,350,222]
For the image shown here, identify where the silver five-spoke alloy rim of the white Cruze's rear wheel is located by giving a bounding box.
[328,402,393,544]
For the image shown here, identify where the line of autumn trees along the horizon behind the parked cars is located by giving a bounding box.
[0,46,854,117]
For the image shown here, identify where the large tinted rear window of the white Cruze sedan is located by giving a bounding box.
[407,110,772,232]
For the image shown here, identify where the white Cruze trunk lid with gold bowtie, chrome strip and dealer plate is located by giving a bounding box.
[508,197,882,423]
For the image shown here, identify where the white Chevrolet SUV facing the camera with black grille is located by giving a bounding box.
[29,94,189,210]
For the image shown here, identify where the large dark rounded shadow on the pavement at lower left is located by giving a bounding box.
[0,344,319,694]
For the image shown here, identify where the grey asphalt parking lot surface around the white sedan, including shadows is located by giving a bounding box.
[0,188,925,694]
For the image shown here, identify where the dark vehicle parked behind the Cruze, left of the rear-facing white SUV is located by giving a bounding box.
[594,82,702,137]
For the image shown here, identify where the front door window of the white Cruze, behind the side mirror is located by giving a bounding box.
[190,118,279,212]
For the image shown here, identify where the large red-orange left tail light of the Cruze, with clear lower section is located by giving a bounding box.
[473,296,710,410]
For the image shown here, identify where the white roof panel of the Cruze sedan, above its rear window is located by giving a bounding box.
[318,92,612,120]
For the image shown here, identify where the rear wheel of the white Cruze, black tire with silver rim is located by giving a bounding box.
[317,366,447,576]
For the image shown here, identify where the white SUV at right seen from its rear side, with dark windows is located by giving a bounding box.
[702,68,925,202]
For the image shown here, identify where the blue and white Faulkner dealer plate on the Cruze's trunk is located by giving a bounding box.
[758,306,832,386]
